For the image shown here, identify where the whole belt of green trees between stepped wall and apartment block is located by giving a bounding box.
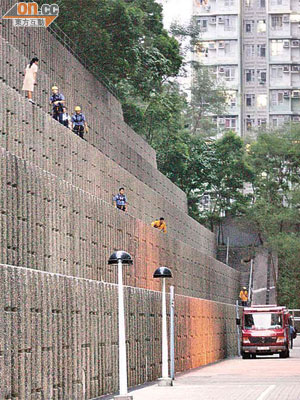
[38,0,300,308]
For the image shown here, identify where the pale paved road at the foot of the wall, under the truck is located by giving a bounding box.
[131,337,300,400]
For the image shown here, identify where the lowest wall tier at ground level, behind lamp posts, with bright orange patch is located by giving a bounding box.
[0,265,236,400]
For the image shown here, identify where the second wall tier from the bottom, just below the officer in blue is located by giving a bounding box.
[0,149,239,303]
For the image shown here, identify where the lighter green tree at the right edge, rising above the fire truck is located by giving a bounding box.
[246,126,300,307]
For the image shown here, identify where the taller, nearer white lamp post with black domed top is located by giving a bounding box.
[108,251,133,400]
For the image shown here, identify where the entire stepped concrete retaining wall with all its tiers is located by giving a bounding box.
[0,0,240,400]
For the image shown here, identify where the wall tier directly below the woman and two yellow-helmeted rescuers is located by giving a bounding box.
[0,83,215,255]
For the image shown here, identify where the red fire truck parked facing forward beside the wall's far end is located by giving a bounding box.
[241,305,290,359]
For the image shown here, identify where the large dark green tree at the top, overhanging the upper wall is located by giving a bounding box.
[39,0,182,111]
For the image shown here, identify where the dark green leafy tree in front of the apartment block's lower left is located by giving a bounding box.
[156,130,253,231]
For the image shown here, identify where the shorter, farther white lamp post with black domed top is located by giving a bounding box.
[153,267,173,386]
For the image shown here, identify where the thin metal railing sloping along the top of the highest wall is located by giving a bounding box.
[47,22,120,99]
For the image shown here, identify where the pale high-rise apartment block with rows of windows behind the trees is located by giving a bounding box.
[193,0,300,136]
